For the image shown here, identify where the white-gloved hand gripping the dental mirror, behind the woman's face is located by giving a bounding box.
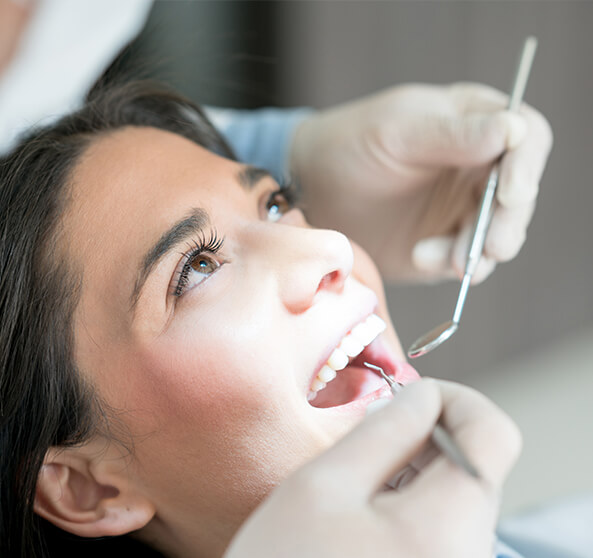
[291,83,552,282]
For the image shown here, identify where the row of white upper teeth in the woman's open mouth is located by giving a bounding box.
[307,314,387,401]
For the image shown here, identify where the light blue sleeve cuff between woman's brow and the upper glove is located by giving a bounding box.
[206,107,312,182]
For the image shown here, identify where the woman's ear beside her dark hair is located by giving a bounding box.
[34,440,155,537]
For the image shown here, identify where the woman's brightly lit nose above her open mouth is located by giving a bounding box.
[277,227,354,314]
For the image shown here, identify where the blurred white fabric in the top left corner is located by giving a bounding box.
[0,0,152,153]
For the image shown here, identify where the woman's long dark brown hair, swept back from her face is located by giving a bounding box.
[0,82,233,558]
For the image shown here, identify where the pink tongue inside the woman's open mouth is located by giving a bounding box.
[311,365,384,409]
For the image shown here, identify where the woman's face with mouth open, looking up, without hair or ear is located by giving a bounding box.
[65,128,415,556]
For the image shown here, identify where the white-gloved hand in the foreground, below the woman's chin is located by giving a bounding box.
[225,380,520,558]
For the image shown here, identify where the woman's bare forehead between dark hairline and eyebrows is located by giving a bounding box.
[64,127,241,336]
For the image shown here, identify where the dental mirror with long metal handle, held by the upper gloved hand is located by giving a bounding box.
[408,37,537,358]
